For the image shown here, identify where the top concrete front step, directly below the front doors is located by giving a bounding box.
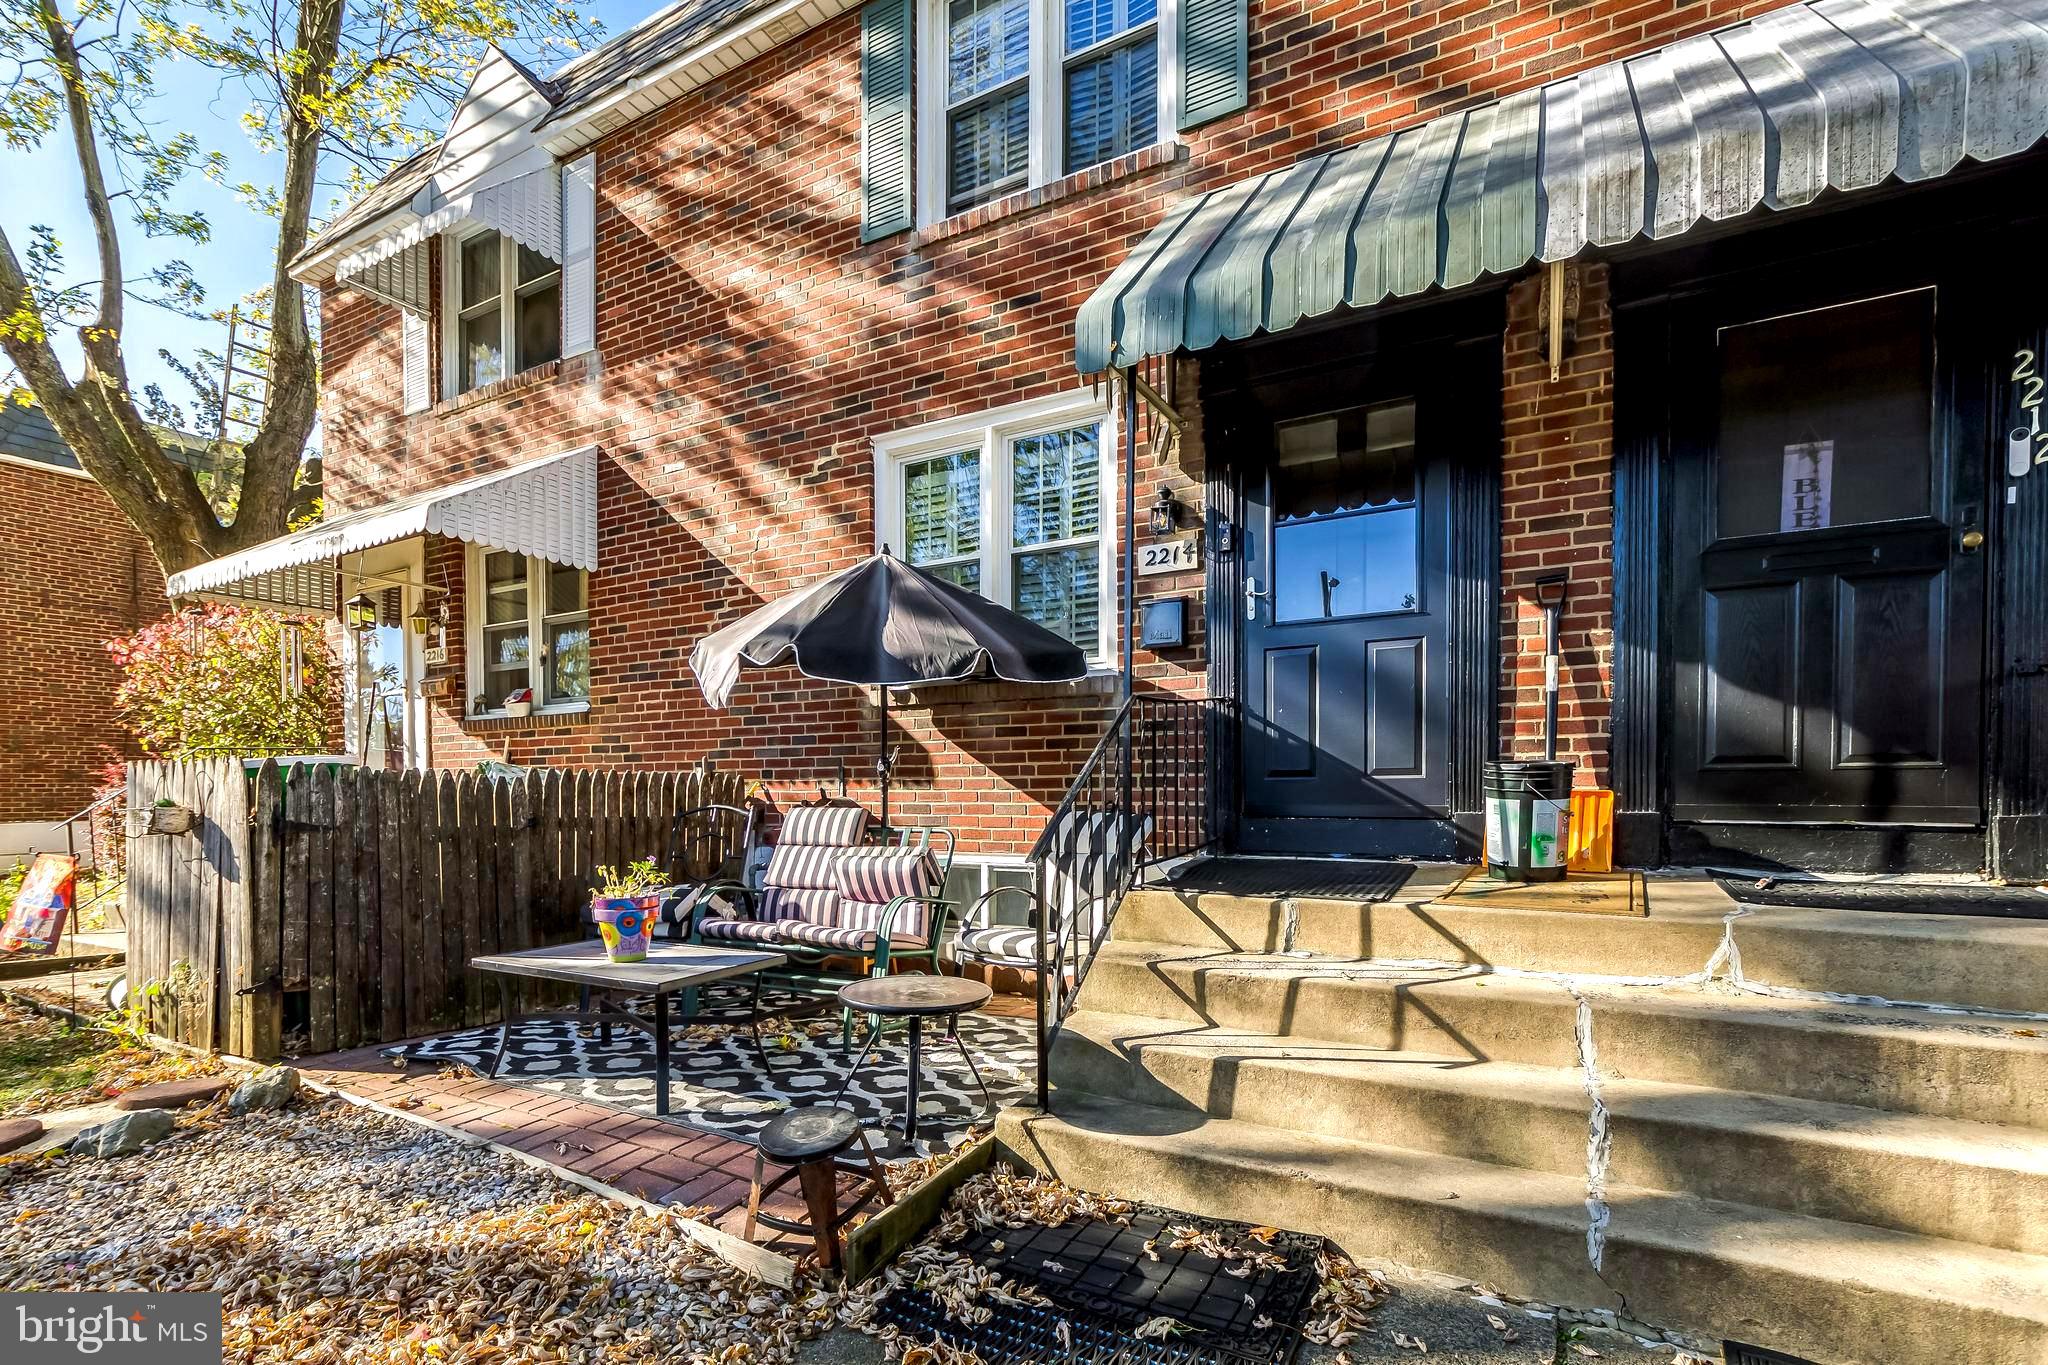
[1114,866,2048,1011]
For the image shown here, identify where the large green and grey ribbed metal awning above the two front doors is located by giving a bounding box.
[1075,0,2048,375]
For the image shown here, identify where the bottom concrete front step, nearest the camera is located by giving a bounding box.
[995,1093,2048,1365]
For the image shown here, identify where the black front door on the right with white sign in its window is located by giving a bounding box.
[1669,280,1985,825]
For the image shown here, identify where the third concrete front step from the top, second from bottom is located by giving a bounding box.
[1053,1011,2048,1254]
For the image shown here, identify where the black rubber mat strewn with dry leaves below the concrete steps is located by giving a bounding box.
[881,1205,1323,1365]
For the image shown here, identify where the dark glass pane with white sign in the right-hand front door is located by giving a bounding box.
[1714,289,1935,536]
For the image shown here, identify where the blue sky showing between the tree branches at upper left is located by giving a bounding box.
[0,0,666,429]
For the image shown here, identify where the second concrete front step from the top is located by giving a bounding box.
[1089,941,2048,1128]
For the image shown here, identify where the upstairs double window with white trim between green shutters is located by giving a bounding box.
[918,0,1180,221]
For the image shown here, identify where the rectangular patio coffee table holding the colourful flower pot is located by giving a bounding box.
[469,939,784,1113]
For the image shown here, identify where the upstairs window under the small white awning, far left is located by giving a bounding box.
[442,231,561,393]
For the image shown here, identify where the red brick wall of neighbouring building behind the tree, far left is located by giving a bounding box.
[0,458,170,821]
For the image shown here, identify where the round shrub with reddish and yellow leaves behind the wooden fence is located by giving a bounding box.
[106,604,340,759]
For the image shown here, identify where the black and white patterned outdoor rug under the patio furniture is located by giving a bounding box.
[385,988,1038,1160]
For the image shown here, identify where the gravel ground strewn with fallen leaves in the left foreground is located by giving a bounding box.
[0,1099,836,1365]
